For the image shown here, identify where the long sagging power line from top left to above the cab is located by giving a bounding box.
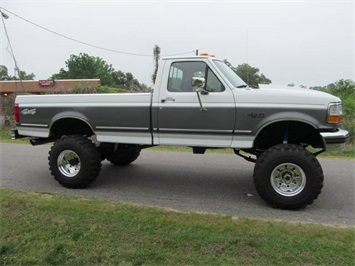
[0,7,195,57]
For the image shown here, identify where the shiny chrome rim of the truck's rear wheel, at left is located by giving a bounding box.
[57,150,81,177]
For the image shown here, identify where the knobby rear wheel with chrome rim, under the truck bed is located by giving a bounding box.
[48,135,101,188]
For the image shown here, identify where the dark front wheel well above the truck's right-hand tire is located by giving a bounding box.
[254,121,323,151]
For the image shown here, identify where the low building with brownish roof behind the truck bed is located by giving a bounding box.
[0,79,100,96]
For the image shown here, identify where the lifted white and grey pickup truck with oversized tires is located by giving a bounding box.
[13,56,349,209]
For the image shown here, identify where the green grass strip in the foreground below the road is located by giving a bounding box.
[0,189,355,265]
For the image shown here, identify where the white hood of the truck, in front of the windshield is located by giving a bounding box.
[233,86,341,107]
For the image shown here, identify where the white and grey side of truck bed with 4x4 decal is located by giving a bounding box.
[16,93,152,144]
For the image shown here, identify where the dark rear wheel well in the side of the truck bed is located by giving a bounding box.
[50,118,94,138]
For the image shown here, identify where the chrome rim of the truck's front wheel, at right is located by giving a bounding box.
[270,163,306,197]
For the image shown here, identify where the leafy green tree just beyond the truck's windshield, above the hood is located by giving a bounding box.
[224,59,271,86]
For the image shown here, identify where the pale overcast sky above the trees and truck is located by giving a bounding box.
[0,0,355,86]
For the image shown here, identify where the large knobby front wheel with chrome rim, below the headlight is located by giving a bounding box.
[254,144,324,210]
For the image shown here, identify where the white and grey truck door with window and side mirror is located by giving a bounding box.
[157,61,235,147]
